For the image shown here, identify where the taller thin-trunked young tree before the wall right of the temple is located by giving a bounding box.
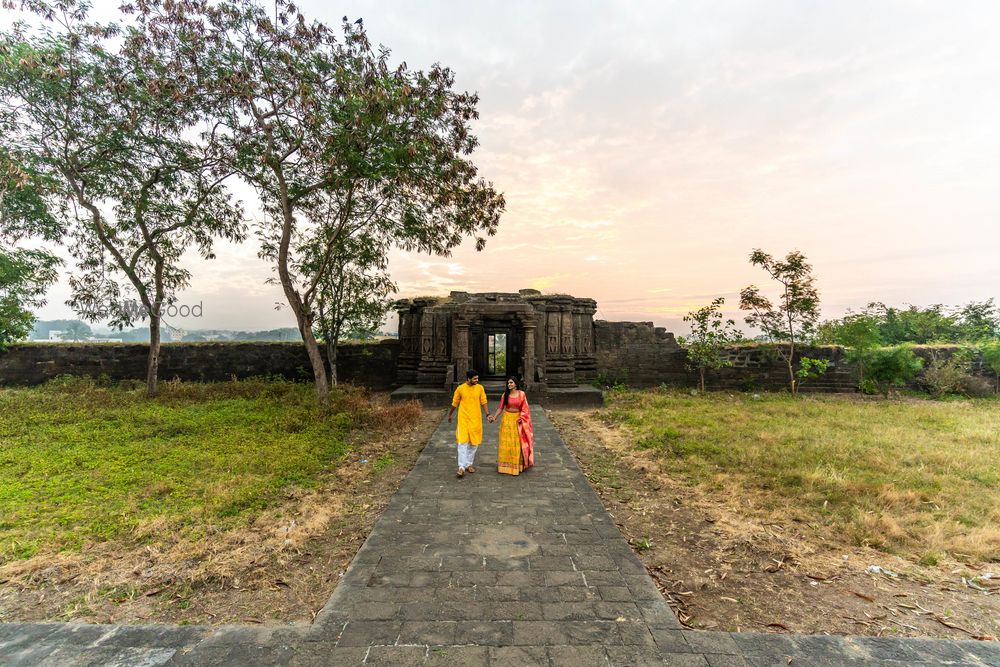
[740,249,819,394]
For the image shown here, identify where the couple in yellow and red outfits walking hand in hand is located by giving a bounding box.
[448,370,535,477]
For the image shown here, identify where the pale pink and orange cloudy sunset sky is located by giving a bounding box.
[17,0,1000,333]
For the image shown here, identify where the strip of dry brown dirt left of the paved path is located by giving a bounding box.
[0,410,442,625]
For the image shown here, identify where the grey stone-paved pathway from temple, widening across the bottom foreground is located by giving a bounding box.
[0,409,1000,667]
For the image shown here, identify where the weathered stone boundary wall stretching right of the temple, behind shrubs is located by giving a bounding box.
[594,320,994,392]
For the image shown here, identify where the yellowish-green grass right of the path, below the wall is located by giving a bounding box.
[600,389,1000,564]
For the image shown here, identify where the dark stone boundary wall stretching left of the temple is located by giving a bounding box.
[0,339,399,390]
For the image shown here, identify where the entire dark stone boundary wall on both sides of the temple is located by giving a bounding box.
[0,320,994,392]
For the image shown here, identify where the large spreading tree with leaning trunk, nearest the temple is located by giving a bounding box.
[130,0,504,404]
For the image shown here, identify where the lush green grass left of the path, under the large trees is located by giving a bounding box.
[0,380,367,564]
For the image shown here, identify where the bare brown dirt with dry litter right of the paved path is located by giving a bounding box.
[549,411,1000,639]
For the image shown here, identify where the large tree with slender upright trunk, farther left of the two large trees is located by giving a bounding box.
[0,0,243,395]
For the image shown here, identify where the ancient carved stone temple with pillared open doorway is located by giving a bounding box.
[395,289,599,402]
